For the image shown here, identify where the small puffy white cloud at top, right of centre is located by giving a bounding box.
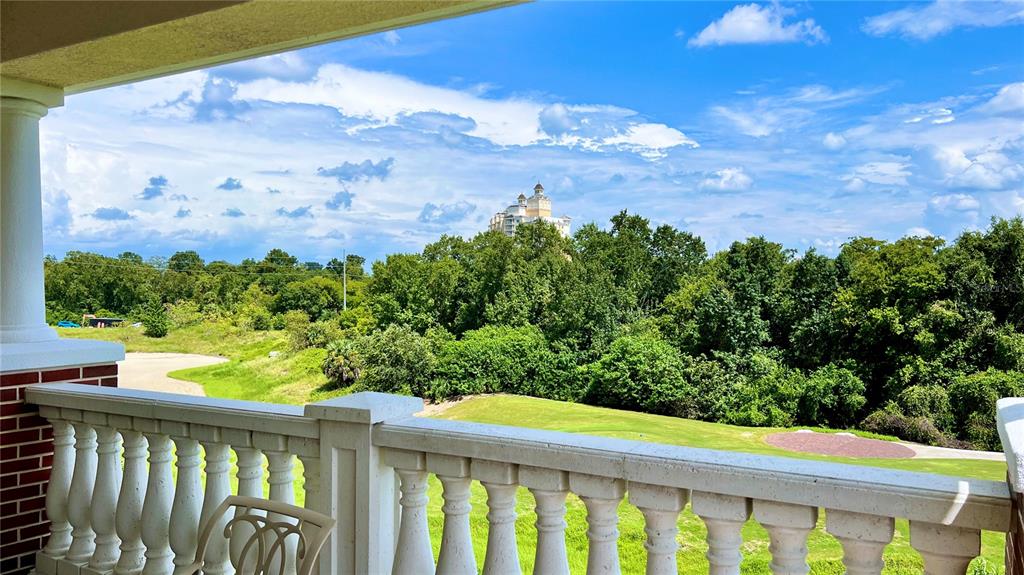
[688,3,828,47]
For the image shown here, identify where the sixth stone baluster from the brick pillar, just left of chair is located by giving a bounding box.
[169,433,199,575]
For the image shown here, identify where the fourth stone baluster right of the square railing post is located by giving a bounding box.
[519,466,569,575]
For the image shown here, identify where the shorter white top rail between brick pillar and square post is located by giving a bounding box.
[26,384,319,438]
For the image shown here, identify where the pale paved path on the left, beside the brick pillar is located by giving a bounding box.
[118,353,227,396]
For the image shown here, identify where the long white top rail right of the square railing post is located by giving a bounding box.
[373,411,1010,531]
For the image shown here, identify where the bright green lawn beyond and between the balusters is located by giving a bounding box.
[60,323,1006,574]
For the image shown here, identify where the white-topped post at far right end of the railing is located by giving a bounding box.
[995,397,1024,575]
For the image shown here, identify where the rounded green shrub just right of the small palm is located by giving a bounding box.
[356,325,434,397]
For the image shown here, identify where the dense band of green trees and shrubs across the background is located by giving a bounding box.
[46,212,1024,448]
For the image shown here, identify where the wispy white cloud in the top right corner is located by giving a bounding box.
[863,0,1024,40]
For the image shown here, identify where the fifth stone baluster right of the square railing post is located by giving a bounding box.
[569,474,626,575]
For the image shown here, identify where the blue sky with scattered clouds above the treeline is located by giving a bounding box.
[42,1,1024,262]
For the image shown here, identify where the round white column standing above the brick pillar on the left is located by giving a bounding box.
[0,95,57,345]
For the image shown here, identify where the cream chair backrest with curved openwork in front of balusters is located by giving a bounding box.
[193,495,335,575]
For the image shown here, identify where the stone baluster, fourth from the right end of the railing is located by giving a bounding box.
[690,491,751,575]
